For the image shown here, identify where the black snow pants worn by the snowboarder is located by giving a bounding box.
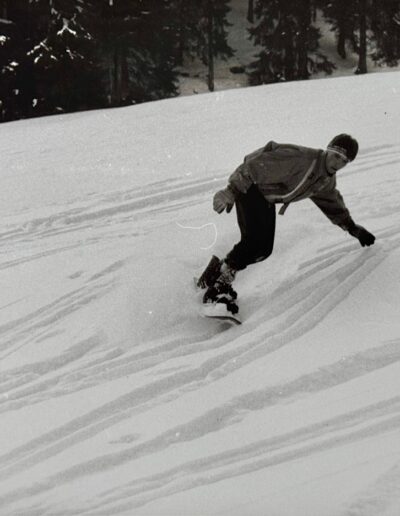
[225,185,276,270]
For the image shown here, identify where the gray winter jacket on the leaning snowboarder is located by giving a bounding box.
[228,141,354,230]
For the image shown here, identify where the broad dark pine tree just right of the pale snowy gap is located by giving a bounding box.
[250,0,334,84]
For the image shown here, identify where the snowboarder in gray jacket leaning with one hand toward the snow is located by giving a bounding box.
[198,134,375,314]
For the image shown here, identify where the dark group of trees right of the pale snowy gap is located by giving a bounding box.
[248,0,400,84]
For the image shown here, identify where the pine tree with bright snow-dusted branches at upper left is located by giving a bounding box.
[23,0,101,115]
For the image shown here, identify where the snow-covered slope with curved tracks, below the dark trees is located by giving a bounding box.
[0,73,400,516]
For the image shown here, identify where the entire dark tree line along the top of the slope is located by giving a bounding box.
[0,0,400,121]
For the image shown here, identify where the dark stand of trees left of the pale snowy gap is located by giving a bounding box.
[0,0,232,121]
